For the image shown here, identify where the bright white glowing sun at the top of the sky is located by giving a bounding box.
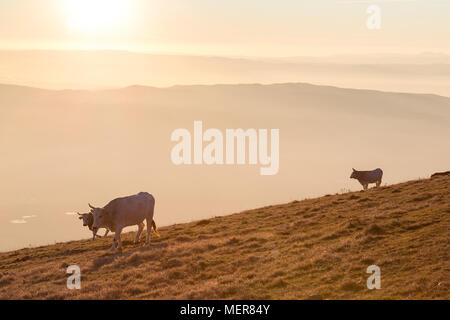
[64,0,129,34]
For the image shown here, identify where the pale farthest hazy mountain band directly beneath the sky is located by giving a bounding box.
[0,51,450,96]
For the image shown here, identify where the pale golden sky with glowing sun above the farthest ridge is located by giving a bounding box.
[0,0,450,56]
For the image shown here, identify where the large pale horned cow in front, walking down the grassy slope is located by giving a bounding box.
[88,192,160,251]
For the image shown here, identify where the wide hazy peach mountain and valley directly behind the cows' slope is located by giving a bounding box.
[0,83,450,250]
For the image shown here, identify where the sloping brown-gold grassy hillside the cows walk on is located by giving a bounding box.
[0,175,450,299]
